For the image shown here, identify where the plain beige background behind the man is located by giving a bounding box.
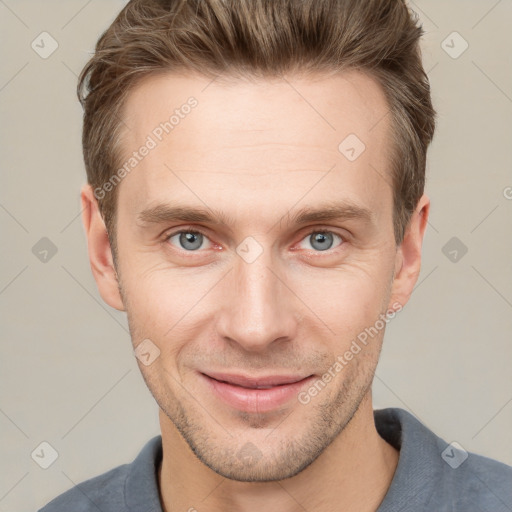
[0,0,512,512]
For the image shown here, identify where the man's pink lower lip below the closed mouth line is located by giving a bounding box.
[201,374,314,413]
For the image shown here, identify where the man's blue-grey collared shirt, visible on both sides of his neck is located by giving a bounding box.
[39,408,512,512]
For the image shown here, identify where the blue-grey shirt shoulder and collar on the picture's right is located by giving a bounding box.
[374,408,512,512]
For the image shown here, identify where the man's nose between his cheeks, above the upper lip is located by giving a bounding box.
[217,251,300,352]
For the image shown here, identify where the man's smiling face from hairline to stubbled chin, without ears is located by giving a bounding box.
[106,72,406,481]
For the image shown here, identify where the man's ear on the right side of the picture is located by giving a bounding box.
[388,195,430,310]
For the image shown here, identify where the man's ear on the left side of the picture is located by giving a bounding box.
[80,184,125,311]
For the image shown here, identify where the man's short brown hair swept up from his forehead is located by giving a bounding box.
[78,0,436,252]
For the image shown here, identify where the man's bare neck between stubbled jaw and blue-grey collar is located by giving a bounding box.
[158,392,399,512]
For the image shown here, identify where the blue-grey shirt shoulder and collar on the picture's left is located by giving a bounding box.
[38,435,162,512]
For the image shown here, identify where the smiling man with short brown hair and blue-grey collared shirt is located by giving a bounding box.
[42,0,512,512]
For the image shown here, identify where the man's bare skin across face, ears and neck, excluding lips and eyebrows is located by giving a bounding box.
[82,71,430,512]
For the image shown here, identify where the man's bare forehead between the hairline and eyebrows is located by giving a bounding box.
[119,71,392,228]
